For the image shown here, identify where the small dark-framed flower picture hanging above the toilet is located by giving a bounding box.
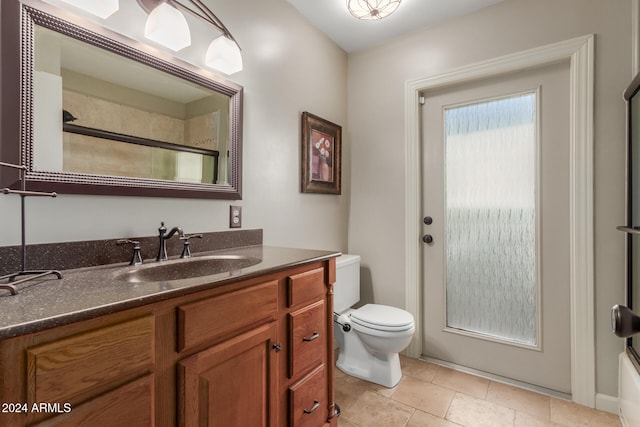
[301,111,342,194]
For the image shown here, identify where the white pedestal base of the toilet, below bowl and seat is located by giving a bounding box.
[336,332,402,388]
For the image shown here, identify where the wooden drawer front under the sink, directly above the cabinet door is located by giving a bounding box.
[178,280,278,352]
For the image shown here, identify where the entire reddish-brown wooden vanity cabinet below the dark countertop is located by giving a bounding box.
[0,259,337,427]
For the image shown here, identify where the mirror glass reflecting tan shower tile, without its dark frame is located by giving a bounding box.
[33,26,229,185]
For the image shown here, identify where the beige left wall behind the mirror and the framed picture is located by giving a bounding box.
[0,0,349,254]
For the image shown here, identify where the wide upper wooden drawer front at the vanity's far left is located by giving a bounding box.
[27,316,154,404]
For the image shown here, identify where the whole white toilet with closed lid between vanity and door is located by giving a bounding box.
[333,255,416,387]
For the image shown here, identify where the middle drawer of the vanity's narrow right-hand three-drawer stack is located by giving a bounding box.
[288,300,327,378]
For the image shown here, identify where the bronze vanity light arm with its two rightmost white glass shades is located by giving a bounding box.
[138,0,242,74]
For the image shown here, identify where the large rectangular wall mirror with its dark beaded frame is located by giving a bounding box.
[0,1,243,199]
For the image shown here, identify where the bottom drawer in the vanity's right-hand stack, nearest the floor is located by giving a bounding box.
[289,365,329,427]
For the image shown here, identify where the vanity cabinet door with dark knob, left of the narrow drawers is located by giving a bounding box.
[178,322,277,427]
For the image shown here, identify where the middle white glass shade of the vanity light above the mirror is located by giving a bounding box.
[144,3,191,51]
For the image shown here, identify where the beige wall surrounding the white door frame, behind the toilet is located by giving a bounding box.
[348,0,632,396]
